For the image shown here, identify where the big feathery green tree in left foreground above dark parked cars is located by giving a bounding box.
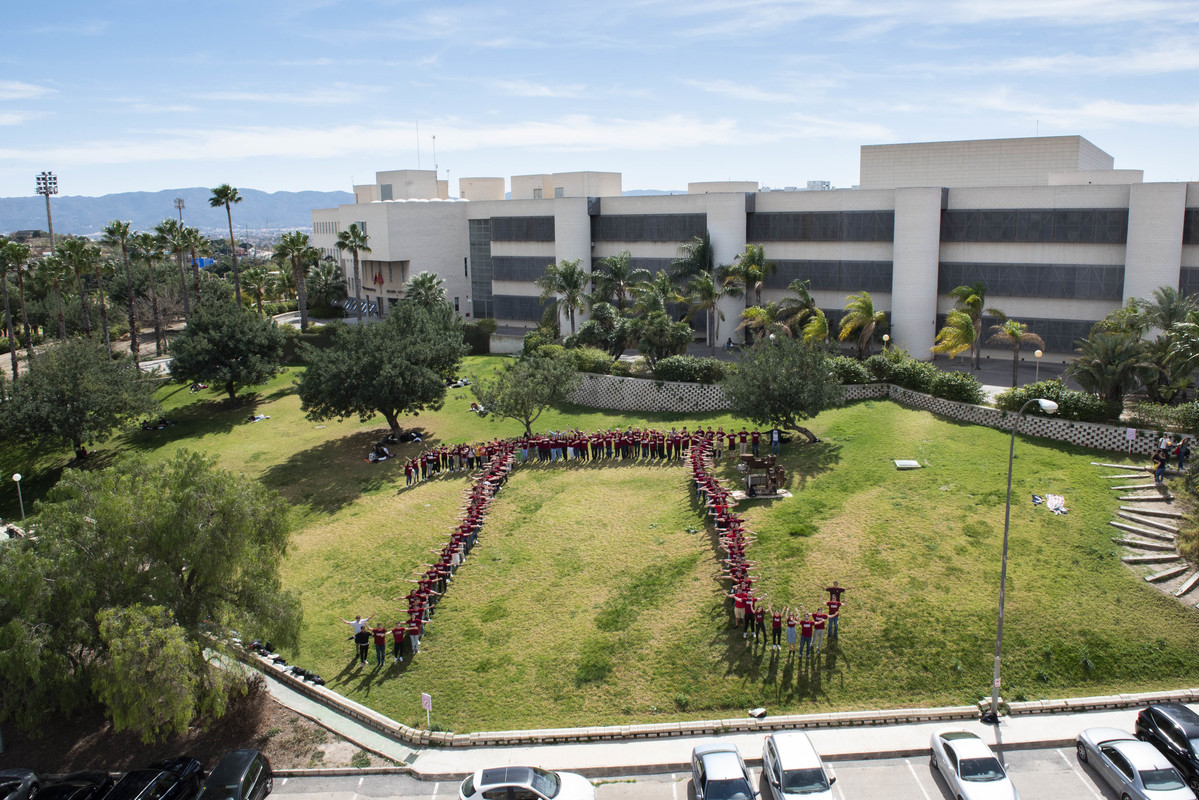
[0,451,300,741]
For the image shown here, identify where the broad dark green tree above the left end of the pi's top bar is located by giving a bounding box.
[297,299,468,434]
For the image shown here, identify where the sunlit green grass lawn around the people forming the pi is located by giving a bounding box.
[5,357,1199,732]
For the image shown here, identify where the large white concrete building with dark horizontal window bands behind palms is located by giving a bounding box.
[313,137,1199,356]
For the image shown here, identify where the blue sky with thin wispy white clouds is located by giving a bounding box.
[0,0,1199,197]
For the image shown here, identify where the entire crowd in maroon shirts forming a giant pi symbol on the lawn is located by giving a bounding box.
[342,427,846,667]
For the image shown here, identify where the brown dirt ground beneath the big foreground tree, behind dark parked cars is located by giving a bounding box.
[0,692,391,775]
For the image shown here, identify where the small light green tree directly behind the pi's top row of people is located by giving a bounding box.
[471,353,583,435]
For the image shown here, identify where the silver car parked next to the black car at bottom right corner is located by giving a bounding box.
[1076,728,1195,800]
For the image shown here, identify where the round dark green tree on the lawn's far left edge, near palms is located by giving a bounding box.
[170,297,283,402]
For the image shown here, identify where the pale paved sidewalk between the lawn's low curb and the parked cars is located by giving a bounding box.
[257,680,1184,781]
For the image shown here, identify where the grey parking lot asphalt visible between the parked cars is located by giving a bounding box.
[275,750,1116,800]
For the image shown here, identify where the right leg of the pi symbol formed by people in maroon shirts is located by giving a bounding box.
[688,439,849,657]
